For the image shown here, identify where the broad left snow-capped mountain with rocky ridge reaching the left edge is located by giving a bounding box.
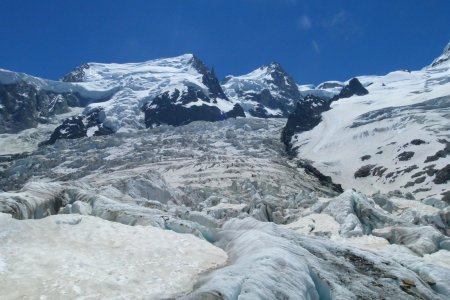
[0,54,245,150]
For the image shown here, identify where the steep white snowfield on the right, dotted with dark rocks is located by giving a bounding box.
[293,52,450,199]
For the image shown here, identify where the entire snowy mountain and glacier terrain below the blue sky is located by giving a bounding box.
[0,42,450,300]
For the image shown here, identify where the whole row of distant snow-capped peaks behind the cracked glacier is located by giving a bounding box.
[0,54,330,148]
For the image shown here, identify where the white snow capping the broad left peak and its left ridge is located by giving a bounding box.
[0,54,234,137]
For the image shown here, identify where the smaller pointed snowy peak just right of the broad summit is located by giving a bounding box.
[222,62,302,118]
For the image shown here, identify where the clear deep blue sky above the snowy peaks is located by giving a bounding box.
[0,0,450,84]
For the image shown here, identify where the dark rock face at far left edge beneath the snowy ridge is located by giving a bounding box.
[0,81,84,133]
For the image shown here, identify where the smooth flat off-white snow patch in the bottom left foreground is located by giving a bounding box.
[0,213,227,299]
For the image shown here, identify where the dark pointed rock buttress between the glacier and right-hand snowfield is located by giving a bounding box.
[281,95,331,155]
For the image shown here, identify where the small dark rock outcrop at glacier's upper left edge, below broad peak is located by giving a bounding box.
[40,108,114,146]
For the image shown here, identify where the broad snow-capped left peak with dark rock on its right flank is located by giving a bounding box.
[63,54,244,132]
